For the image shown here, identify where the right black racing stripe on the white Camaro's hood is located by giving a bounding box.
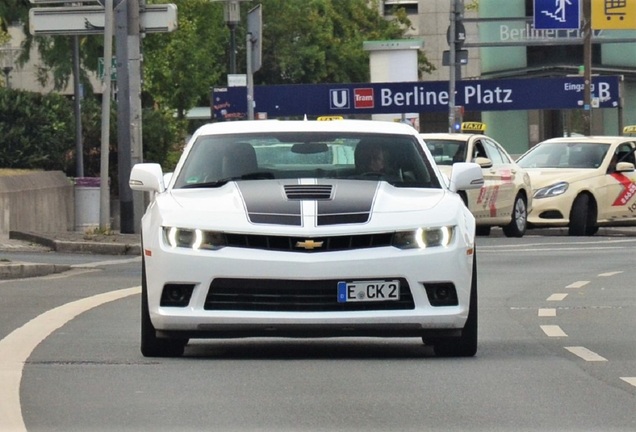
[317,181,379,225]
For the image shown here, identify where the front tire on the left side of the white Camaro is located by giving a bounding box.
[141,259,188,357]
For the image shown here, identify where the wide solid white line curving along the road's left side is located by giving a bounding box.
[0,287,141,432]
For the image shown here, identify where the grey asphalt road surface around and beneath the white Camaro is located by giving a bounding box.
[0,234,636,432]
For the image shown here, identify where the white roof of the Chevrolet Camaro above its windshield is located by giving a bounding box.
[195,120,418,136]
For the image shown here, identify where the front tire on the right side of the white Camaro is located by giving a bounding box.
[433,252,478,357]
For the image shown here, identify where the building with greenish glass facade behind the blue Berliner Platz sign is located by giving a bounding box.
[381,0,636,154]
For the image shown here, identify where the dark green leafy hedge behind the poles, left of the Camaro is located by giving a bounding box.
[0,88,185,188]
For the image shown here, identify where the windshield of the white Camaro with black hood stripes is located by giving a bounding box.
[174,132,440,188]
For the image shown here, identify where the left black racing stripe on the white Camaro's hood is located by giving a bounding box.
[236,181,302,226]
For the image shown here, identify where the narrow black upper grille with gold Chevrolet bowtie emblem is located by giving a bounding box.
[225,233,393,252]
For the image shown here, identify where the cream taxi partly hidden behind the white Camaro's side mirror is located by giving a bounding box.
[420,122,532,237]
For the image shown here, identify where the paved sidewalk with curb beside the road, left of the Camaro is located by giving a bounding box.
[0,231,141,280]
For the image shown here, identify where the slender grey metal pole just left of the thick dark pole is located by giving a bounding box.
[99,0,113,229]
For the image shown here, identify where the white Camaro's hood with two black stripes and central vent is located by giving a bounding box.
[153,179,454,232]
